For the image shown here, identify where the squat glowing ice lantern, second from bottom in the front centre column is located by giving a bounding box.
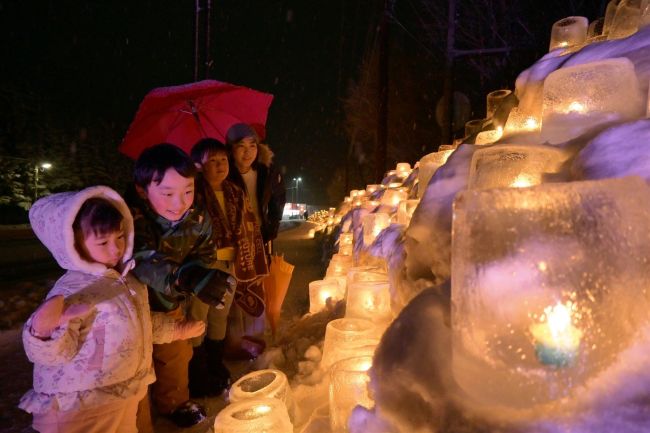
[321,318,379,370]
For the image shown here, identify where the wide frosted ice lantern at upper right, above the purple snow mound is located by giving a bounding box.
[542,58,645,144]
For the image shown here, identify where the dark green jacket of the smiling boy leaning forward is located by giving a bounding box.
[125,189,217,311]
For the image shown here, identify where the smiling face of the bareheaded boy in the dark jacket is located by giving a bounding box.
[138,167,194,221]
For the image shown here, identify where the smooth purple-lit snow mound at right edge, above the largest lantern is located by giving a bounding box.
[572,120,650,181]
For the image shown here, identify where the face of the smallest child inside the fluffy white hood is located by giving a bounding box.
[75,223,126,268]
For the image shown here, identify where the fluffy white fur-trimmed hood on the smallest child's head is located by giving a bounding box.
[29,186,133,275]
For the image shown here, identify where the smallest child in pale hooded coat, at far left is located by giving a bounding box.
[20,186,204,433]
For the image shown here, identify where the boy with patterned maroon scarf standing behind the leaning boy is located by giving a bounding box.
[190,138,268,397]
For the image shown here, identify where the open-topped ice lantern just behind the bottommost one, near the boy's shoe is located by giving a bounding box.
[228,369,293,413]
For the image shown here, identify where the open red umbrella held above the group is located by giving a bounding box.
[119,80,273,159]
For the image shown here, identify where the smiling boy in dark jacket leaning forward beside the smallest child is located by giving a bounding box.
[127,143,236,427]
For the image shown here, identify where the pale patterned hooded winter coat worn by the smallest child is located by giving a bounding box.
[19,186,175,413]
